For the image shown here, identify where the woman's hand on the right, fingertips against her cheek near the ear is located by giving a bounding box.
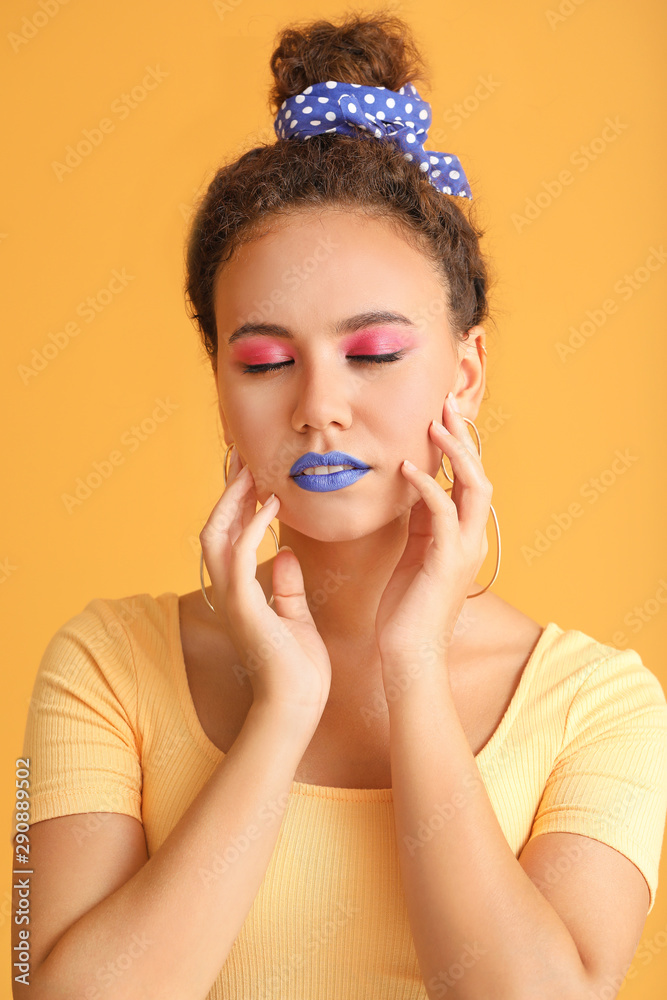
[375,393,493,688]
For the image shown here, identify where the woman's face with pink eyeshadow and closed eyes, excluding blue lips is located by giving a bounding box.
[215,209,483,541]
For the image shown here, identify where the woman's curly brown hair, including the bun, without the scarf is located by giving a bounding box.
[185,5,496,370]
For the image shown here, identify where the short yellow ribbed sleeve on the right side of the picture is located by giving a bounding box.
[530,649,667,913]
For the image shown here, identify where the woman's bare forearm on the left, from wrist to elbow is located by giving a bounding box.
[24,704,314,1000]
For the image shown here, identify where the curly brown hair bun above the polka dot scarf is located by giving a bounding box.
[269,11,428,114]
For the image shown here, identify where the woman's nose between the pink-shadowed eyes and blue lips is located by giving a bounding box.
[292,357,354,432]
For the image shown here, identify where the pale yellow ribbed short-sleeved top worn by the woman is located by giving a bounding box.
[23,593,667,1000]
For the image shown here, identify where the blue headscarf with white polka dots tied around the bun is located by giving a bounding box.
[273,80,472,199]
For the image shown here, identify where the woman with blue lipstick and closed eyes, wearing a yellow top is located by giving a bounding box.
[14,9,667,1000]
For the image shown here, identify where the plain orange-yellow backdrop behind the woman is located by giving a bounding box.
[0,0,667,1000]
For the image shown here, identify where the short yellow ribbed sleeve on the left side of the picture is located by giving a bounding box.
[23,598,142,823]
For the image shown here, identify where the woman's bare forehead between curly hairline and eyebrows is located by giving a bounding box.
[215,208,445,325]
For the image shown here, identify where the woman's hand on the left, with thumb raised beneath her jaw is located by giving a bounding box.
[199,447,331,732]
